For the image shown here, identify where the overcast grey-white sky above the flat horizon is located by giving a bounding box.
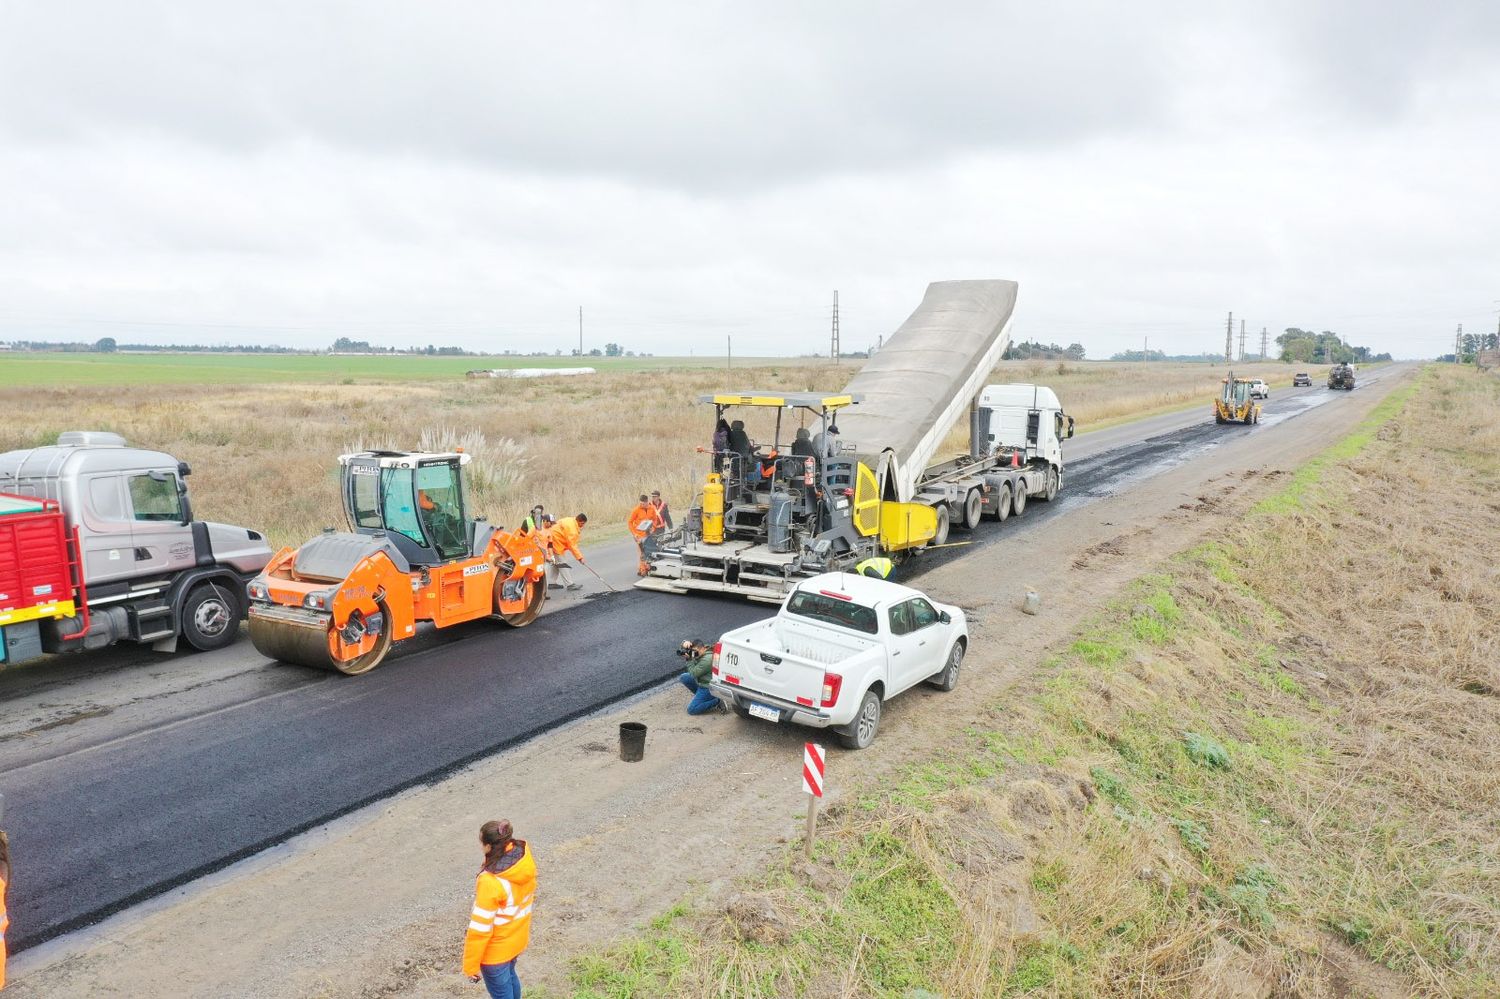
[0,0,1500,357]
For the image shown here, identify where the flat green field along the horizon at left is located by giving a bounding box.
[0,353,786,387]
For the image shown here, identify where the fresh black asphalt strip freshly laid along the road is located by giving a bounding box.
[0,378,1362,951]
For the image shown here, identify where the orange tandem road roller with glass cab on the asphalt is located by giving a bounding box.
[248,452,548,675]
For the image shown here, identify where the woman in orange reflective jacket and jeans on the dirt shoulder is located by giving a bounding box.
[464,819,537,999]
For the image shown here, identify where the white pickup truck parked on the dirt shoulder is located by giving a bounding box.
[710,573,969,749]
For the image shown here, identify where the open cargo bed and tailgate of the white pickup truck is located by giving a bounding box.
[719,618,875,707]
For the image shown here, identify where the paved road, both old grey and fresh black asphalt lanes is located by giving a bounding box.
[0,369,1394,950]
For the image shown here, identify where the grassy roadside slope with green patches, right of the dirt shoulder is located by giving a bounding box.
[555,369,1500,999]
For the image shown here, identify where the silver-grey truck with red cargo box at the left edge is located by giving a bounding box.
[0,431,272,665]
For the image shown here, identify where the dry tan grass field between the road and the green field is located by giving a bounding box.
[0,360,1320,545]
